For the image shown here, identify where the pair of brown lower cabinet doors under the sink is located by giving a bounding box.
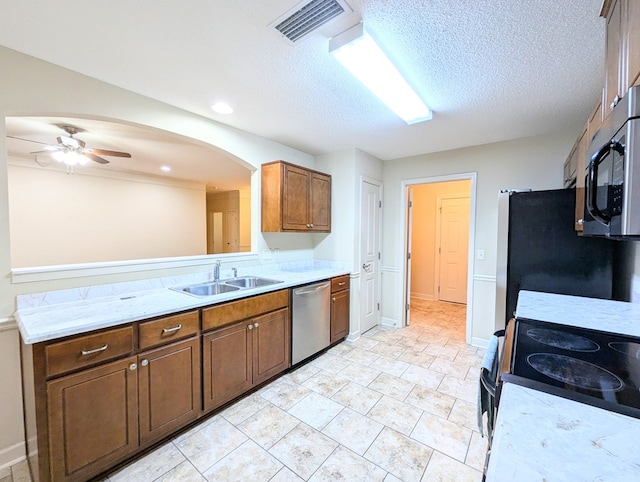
[202,308,291,411]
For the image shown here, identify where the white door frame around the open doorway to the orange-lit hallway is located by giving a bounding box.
[398,172,478,343]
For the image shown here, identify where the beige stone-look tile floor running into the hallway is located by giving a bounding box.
[0,300,486,482]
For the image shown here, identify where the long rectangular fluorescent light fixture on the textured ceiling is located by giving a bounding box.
[329,22,432,124]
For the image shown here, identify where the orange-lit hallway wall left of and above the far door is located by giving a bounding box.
[411,181,471,300]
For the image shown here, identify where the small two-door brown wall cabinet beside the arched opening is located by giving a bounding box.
[262,161,331,233]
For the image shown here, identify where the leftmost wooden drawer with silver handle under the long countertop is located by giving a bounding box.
[45,326,133,377]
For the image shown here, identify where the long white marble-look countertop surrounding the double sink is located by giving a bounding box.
[14,260,349,344]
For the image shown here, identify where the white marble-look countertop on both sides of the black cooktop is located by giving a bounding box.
[486,291,640,482]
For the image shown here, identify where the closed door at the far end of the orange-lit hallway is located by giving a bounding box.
[437,197,469,303]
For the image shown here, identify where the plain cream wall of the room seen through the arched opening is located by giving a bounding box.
[8,163,206,268]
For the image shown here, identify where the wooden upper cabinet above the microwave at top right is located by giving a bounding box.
[600,0,640,119]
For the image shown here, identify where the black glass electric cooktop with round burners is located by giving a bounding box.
[502,318,640,418]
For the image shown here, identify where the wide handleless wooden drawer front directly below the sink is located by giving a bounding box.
[202,290,289,331]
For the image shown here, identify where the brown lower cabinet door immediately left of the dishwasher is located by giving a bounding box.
[251,309,291,385]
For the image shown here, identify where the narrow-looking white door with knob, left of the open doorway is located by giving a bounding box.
[360,181,382,333]
